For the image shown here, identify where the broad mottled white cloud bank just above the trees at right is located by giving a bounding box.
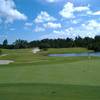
[41,20,100,39]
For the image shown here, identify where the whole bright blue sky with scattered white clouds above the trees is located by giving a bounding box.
[0,0,100,43]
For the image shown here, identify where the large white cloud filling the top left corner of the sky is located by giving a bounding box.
[0,0,27,22]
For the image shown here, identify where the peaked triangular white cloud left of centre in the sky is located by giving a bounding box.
[34,11,56,23]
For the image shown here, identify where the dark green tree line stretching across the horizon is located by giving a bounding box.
[0,36,100,52]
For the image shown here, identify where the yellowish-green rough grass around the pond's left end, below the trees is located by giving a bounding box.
[0,48,96,64]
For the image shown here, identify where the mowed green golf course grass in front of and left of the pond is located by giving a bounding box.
[0,48,100,100]
